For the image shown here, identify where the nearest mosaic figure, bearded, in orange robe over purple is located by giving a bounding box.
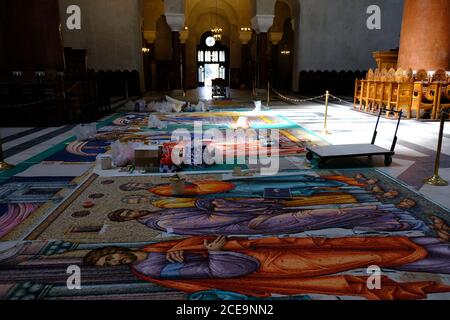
[84,236,450,300]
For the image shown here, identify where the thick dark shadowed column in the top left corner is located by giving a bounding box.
[0,0,64,71]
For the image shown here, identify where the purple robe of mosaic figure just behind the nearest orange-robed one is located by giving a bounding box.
[139,199,429,236]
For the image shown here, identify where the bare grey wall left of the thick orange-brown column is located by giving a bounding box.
[295,0,404,72]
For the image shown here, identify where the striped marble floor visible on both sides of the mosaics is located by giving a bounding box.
[0,89,450,208]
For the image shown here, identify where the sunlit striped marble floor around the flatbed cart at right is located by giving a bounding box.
[272,103,450,208]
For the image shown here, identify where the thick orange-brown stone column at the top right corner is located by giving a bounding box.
[398,0,450,71]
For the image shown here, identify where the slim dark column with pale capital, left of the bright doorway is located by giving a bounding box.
[165,12,184,90]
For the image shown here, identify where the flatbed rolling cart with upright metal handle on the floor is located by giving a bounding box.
[306,109,403,169]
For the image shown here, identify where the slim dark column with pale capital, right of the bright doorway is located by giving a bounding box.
[252,14,275,88]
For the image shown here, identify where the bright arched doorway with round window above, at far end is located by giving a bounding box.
[197,31,230,87]
